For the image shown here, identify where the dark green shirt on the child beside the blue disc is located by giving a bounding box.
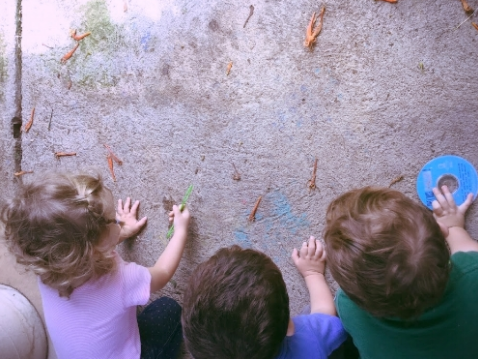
[335,252,478,359]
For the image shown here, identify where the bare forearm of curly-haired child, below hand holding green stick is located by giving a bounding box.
[149,230,187,292]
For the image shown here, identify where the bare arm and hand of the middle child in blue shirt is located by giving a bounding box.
[292,236,337,315]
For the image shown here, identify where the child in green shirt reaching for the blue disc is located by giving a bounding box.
[324,186,478,359]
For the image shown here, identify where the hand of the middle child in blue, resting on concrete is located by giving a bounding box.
[292,236,325,278]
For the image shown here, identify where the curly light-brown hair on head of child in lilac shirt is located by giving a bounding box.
[1,173,115,296]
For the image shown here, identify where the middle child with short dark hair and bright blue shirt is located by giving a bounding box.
[182,237,346,359]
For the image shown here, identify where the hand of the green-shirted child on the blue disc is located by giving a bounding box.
[432,186,473,228]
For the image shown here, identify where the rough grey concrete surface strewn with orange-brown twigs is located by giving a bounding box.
[0,0,478,358]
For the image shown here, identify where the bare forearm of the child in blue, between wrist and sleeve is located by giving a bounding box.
[304,273,337,315]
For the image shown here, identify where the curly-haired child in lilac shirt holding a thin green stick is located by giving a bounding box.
[1,173,189,359]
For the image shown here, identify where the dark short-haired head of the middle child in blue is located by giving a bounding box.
[182,246,289,359]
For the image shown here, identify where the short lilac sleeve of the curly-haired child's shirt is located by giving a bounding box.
[120,262,151,308]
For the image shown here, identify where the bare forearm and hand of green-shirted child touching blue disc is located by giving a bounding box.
[432,186,478,254]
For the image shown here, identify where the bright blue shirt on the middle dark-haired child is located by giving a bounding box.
[276,313,347,359]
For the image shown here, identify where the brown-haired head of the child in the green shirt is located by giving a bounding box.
[324,187,450,319]
